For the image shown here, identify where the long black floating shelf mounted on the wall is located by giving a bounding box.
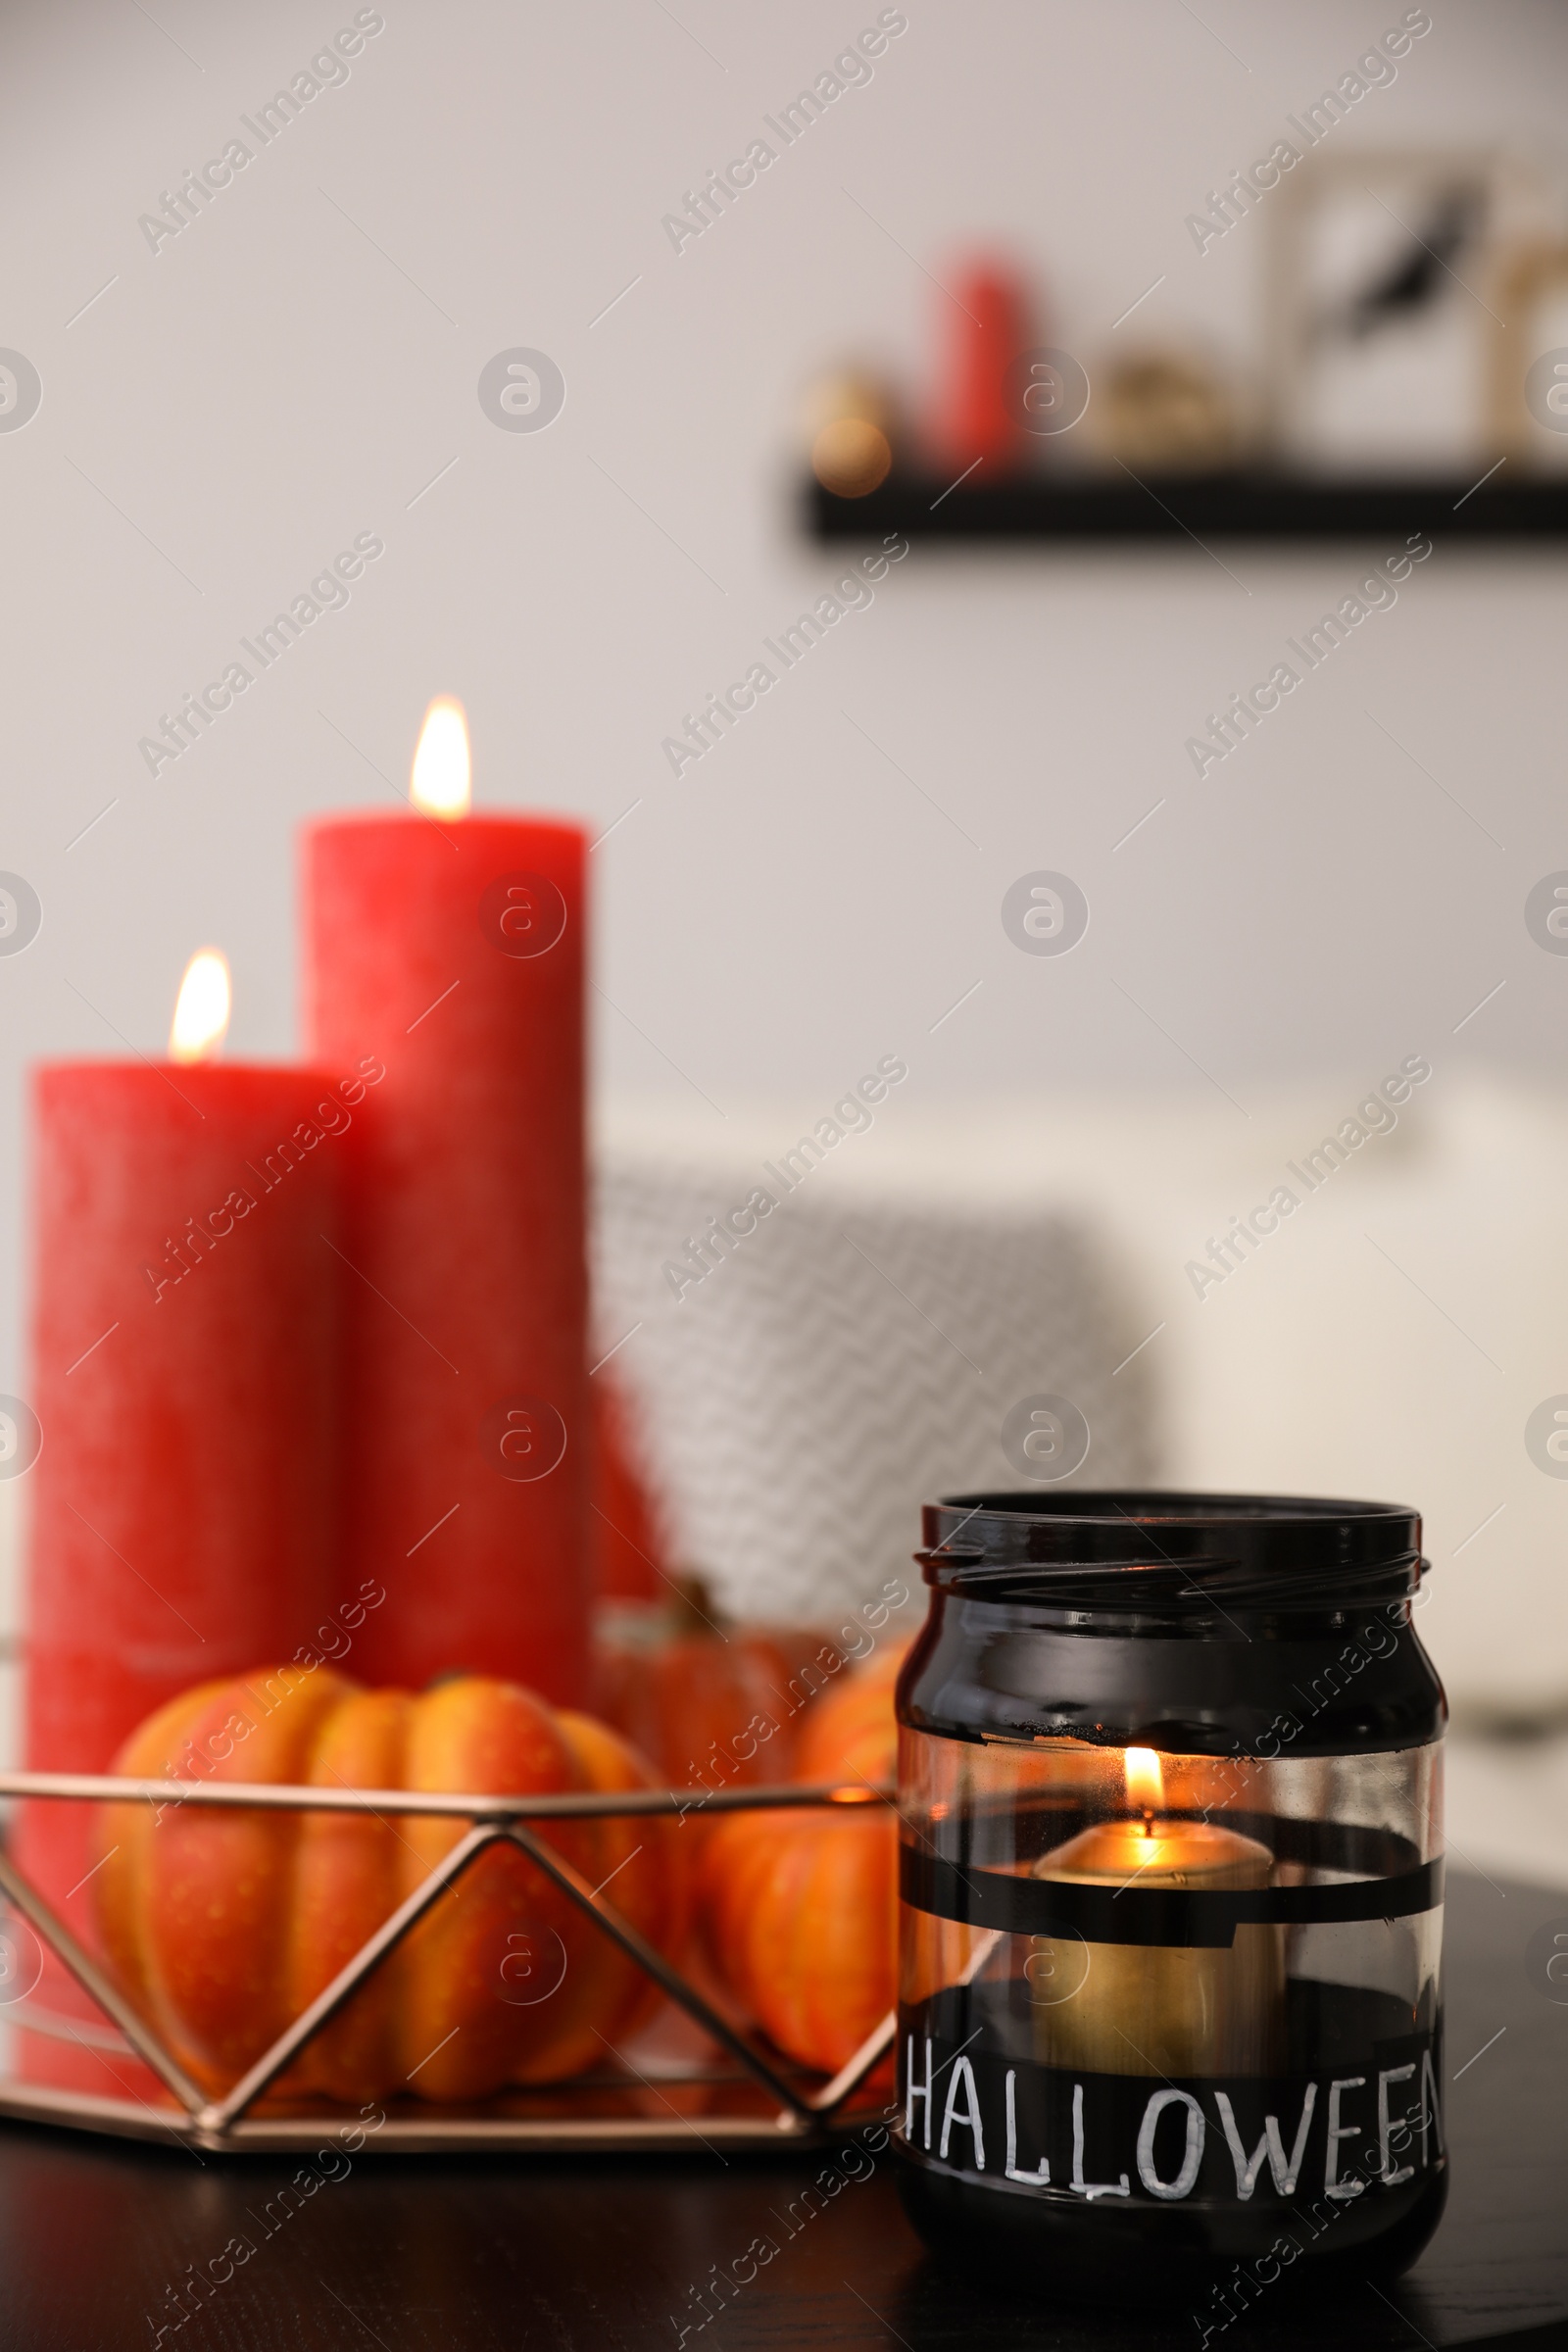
[804,468,1568,546]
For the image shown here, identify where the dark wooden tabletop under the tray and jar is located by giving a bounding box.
[0,1875,1568,2352]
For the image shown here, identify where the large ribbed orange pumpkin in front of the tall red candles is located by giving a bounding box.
[94,1668,686,2105]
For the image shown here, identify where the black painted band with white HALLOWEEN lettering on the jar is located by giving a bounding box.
[898,1987,1444,2221]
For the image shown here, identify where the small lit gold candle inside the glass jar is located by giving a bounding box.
[1027,1747,1284,2077]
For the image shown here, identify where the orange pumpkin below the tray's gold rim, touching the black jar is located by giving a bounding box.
[703,1801,898,2075]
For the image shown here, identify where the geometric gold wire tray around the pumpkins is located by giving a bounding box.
[0,1771,896,2154]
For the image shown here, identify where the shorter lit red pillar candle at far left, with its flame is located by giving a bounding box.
[14,951,345,2079]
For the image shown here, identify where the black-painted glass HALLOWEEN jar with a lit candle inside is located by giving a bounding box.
[896,1492,1446,2295]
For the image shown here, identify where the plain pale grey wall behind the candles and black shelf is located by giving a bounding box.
[0,0,1568,1712]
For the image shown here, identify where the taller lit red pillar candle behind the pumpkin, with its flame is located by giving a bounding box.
[306,699,592,1705]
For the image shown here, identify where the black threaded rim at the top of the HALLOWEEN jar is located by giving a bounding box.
[914,1487,1427,1609]
